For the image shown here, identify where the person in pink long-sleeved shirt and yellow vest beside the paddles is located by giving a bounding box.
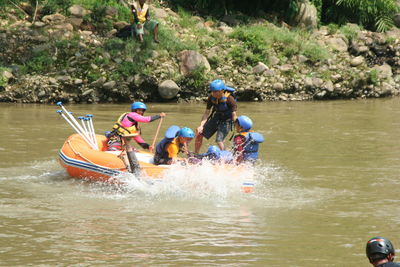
[107,102,165,151]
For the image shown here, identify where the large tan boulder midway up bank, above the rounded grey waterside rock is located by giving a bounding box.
[178,50,211,75]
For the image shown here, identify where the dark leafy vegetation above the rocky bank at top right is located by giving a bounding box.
[169,0,399,31]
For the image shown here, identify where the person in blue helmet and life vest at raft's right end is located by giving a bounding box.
[233,115,264,164]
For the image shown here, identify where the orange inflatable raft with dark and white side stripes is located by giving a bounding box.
[59,134,254,193]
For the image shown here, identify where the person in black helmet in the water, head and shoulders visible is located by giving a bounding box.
[366,236,400,267]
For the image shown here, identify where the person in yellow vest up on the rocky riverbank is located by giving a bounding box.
[131,0,160,43]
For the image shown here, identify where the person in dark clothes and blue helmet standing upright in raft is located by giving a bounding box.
[195,80,237,153]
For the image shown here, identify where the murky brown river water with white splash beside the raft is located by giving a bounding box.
[0,98,400,266]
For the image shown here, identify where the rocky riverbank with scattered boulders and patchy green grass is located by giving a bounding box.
[0,1,400,103]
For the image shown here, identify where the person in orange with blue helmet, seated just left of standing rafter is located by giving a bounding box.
[154,125,194,165]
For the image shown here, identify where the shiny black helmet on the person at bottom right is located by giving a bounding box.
[366,236,394,262]
